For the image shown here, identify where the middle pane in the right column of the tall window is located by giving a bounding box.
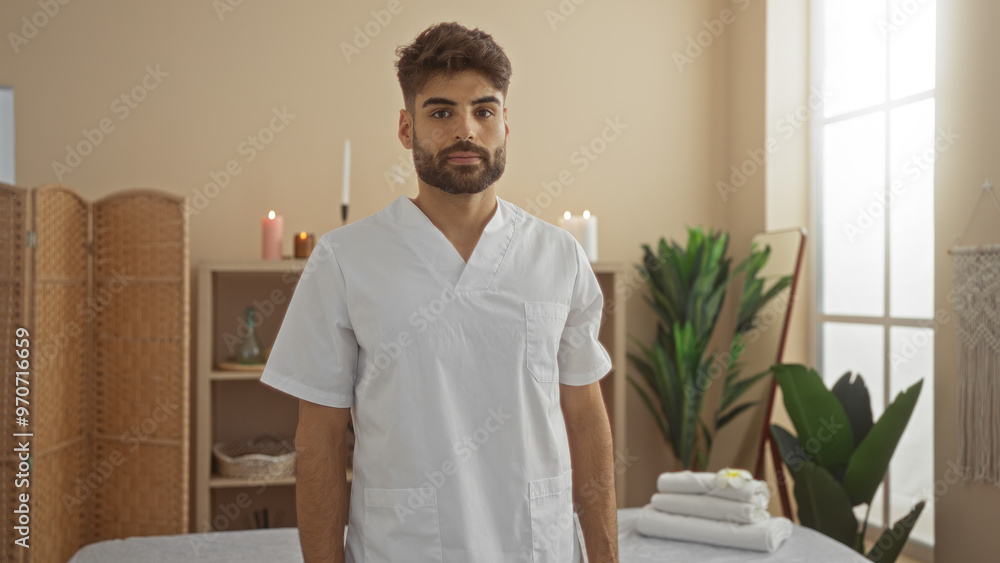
[889,99,947,319]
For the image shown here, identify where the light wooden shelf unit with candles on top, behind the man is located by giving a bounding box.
[192,259,627,532]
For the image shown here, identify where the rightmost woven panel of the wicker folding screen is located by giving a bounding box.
[92,191,190,541]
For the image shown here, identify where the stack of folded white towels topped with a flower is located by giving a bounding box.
[635,468,792,552]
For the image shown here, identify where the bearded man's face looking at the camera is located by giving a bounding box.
[400,71,509,194]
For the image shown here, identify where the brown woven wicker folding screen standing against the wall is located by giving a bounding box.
[2,185,189,563]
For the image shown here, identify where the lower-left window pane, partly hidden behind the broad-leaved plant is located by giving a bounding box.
[822,323,885,526]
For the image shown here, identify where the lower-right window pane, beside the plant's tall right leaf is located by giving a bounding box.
[889,327,935,544]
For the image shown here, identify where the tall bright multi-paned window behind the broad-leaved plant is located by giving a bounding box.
[811,0,936,546]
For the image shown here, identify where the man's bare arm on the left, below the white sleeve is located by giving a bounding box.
[295,400,351,563]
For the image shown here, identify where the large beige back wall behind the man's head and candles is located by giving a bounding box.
[0,0,736,505]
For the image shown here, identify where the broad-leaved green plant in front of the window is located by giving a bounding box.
[771,364,924,563]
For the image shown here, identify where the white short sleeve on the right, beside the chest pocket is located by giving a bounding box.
[558,240,611,385]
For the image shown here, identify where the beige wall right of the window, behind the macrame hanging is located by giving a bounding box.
[934,0,1000,563]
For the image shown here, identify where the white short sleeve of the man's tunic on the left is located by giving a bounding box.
[260,237,358,408]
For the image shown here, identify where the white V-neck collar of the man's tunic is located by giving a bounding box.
[386,194,520,292]
